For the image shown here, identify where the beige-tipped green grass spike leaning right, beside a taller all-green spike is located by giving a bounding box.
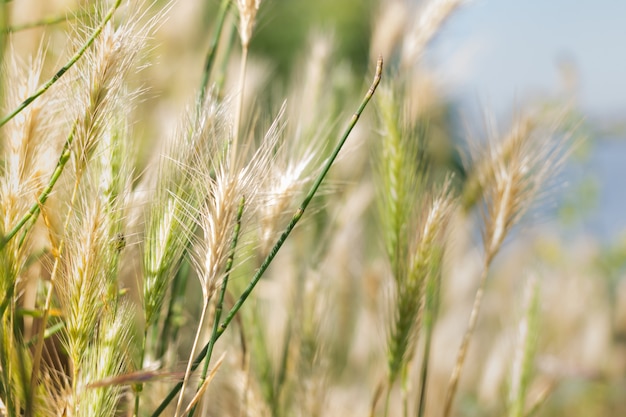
[388,180,455,412]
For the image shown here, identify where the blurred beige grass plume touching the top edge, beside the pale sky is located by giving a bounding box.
[401,0,458,68]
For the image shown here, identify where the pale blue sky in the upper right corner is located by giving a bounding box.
[427,0,626,118]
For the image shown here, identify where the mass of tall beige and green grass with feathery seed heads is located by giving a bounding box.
[0,0,600,417]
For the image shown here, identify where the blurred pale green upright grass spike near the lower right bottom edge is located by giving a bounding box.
[508,276,540,417]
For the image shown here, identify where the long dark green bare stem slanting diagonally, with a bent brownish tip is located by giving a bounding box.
[152,57,383,417]
